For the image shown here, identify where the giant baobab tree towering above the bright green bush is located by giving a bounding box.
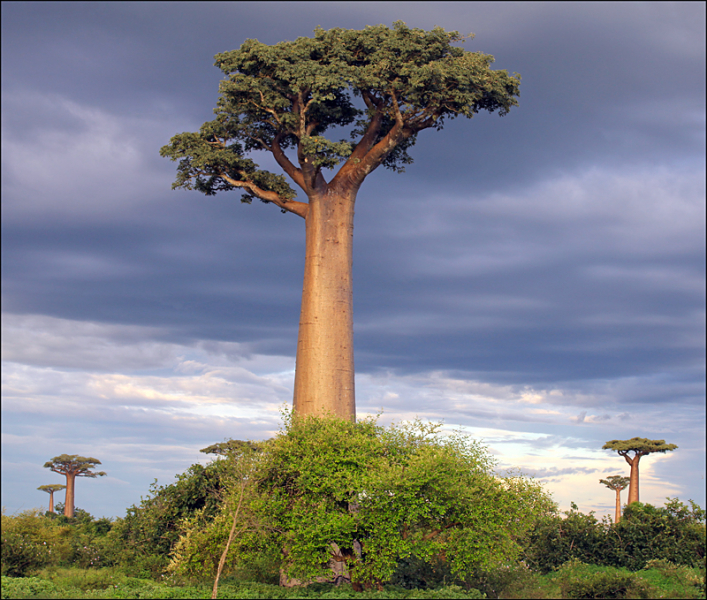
[160,21,520,420]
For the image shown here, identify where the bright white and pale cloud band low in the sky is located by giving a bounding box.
[2,315,703,514]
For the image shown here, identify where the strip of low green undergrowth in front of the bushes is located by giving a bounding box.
[2,561,705,599]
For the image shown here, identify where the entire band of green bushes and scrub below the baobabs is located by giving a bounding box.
[2,417,705,598]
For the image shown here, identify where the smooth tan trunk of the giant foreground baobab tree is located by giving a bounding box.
[293,190,356,421]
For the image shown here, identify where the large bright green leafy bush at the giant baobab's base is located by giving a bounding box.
[166,417,554,583]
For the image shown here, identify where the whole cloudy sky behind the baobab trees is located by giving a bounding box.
[2,2,705,516]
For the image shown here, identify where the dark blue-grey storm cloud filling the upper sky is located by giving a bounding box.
[3,3,703,382]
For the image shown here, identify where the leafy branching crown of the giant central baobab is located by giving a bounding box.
[160,21,520,212]
